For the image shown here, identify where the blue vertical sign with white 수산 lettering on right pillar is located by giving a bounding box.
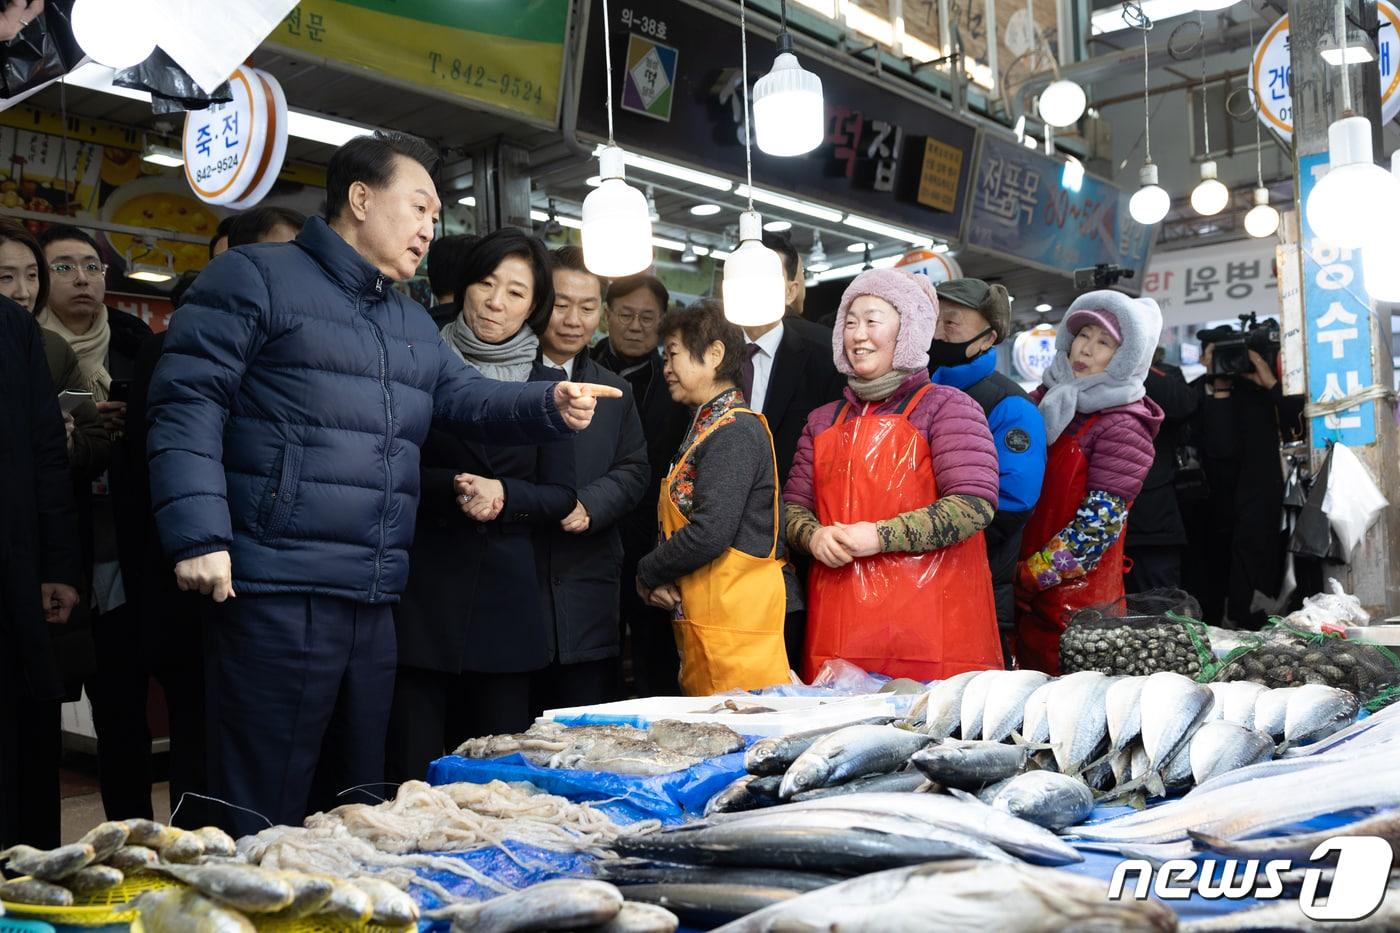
[1298,153,1376,448]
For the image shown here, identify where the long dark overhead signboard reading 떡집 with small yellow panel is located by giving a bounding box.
[578,0,976,238]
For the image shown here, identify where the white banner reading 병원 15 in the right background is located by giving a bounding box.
[1141,237,1278,328]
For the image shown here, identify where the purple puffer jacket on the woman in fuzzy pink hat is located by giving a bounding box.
[783,373,998,518]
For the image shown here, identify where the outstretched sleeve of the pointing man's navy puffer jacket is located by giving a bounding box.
[433,338,574,444]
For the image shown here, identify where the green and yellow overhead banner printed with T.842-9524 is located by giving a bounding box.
[267,0,562,127]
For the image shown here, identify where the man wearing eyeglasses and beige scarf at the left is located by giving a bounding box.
[38,226,151,820]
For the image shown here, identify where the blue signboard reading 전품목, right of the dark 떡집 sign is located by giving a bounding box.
[967,134,1154,281]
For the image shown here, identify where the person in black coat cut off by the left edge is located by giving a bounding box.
[0,297,78,848]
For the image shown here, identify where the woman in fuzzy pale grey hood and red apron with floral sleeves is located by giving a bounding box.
[1016,291,1162,674]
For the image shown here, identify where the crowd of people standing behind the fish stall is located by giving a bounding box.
[0,127,1299,846]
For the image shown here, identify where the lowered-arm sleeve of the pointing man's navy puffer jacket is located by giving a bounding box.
[146,246,270,562]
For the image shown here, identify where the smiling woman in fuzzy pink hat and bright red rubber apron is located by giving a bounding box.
[783,269,1002,681]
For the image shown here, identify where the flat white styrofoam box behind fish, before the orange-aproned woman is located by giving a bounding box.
[540,693,916,737]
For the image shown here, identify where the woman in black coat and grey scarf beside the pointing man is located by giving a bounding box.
[386,228,575,780]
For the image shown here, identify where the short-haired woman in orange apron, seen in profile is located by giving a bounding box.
[637,301,788,696]
